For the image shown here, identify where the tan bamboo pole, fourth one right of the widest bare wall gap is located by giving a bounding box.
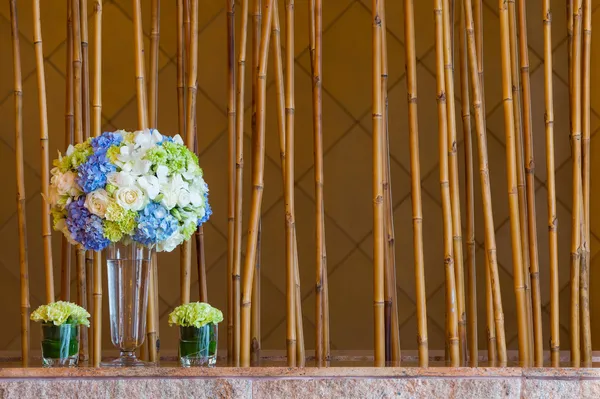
[433,0,460,367]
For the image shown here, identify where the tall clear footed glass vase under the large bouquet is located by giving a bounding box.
[103,242,153,367]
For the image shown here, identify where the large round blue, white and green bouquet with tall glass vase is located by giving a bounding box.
[47,129,212,366]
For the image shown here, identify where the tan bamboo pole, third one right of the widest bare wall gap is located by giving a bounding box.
[404,0,429,367]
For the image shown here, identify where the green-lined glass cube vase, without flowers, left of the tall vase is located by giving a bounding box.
[42,323,79,367]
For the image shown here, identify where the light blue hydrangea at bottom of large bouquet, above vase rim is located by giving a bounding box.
[133,202,179,245]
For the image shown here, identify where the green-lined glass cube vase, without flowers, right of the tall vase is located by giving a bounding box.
[179,323,218,367]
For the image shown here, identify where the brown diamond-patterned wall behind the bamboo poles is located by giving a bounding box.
[0,0,600,350]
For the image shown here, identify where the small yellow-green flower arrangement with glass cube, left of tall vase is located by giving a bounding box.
[31,301,90,367]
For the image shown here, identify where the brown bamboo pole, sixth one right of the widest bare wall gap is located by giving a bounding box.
[458,0,478,367]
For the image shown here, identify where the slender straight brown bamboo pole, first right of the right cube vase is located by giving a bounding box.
[225,0,237,366]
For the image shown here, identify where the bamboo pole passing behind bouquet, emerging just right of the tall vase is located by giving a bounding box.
[146,0,160,363]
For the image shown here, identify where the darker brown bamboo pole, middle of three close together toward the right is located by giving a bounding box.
[508,0,533,361]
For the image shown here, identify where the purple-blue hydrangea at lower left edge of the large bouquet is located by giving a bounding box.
[67,196,110,251]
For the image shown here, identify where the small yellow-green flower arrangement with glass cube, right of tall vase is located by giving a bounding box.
[169,302,223,367]
